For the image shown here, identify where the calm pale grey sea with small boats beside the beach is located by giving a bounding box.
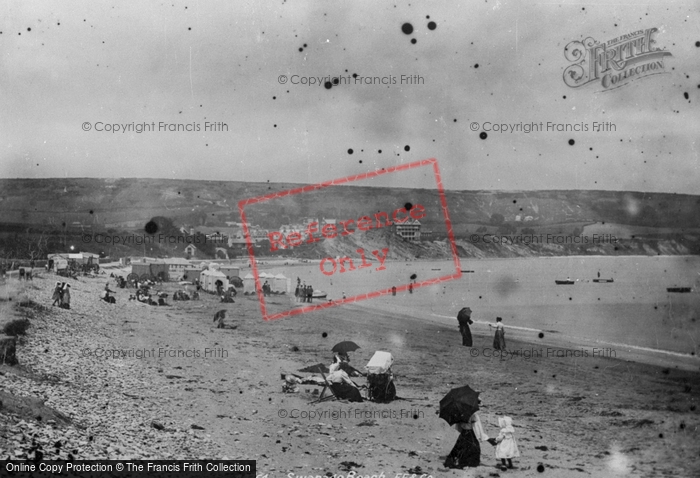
[259,255,700,365]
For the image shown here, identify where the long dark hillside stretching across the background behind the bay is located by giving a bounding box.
[0,178,700,258]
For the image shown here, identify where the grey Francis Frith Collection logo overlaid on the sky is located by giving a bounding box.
[564,28,671,90]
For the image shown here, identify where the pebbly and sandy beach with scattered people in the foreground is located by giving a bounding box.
[0,268,700,477]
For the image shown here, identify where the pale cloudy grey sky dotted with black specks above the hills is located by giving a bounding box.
[0,0,700,194]
